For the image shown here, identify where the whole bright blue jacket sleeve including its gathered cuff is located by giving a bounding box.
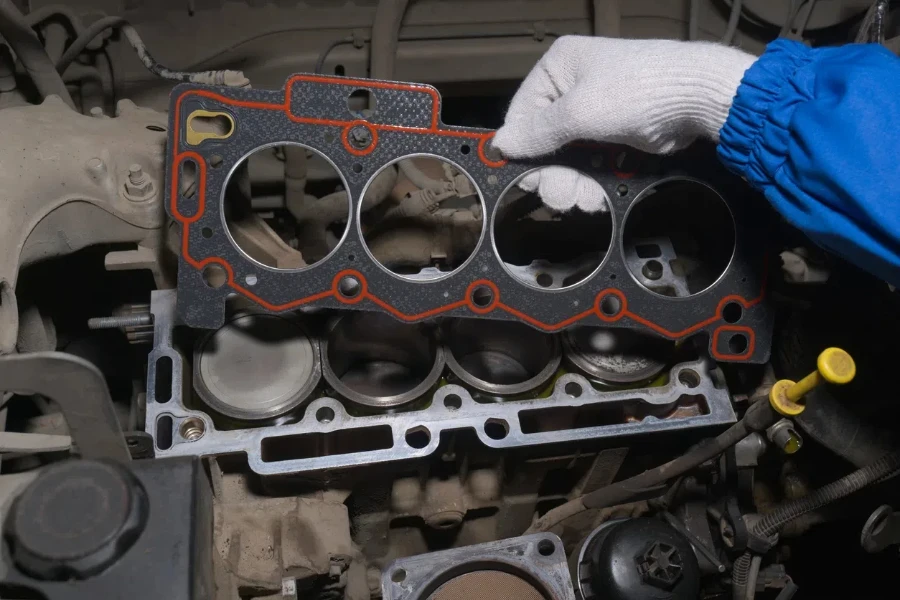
[718,40,900,286]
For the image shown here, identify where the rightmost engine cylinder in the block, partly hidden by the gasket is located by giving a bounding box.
[562,326,675,387]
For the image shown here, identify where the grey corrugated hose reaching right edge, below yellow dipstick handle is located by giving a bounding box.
[731,452,900,600]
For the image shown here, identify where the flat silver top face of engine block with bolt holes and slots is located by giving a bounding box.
[146,290,736,475]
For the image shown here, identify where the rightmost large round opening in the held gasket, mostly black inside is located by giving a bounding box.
[622,179,735,298]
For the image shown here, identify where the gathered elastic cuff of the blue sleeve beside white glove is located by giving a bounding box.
[718,39,812,189]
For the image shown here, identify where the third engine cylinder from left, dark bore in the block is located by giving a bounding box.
[444,319,561,397]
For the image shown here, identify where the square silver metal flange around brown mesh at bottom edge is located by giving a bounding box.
[381,533,575,600]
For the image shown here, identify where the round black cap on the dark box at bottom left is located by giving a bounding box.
[4,460,147,580]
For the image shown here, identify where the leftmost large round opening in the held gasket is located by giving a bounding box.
[223,144,350,270]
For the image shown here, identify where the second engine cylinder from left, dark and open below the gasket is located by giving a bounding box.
[322,313,444,408]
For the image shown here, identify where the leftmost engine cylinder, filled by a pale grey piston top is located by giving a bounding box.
[194,312,322,421]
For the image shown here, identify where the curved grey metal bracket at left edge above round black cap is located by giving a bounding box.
[0,352,131,463]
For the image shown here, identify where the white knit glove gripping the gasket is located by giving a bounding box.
[493,36,756,212]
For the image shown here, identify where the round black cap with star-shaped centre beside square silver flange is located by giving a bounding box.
[584,517,700,600]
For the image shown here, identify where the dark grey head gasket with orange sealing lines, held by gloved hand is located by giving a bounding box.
[166,74,772,363]
